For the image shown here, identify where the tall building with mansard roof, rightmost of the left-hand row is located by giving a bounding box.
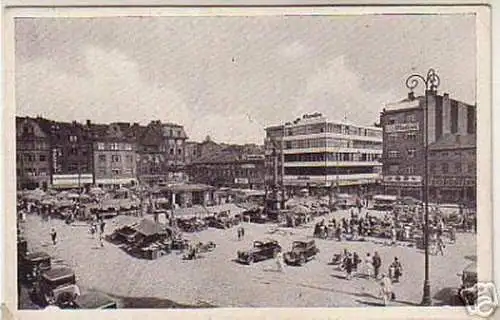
[132,121,187,185]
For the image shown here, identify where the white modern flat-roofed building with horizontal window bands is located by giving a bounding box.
[265,113,382,192]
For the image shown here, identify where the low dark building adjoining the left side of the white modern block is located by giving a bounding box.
[188,146,265,189]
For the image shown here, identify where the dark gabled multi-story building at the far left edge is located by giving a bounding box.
[16,117,52,189]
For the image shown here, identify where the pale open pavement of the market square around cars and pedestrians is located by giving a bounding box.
[17,211,476,307]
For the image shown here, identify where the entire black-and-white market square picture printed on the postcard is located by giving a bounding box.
[5,3,497,316]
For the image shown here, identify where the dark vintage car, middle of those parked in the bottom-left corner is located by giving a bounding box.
[32,267,80,305]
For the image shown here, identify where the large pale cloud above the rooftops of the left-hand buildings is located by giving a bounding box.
[17,47,192,128]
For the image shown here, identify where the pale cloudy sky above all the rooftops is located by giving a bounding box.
[15,15,476,144]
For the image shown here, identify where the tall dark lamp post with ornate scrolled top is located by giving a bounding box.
[406,69,440,306]
